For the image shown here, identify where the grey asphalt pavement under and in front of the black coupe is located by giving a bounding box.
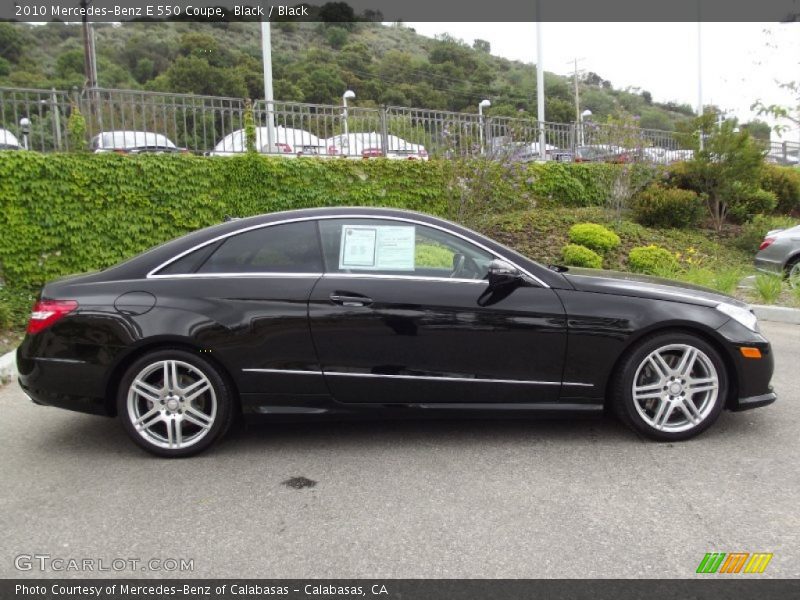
[0,323,800,578]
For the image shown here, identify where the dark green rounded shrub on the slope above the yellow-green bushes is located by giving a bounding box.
[632,184,704,228]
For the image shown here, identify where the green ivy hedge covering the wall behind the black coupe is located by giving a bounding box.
[0,152,616,289]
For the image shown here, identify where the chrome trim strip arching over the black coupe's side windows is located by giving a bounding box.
[145,213,550,288]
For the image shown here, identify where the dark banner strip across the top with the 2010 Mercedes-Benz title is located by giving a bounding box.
[0,0,800,22]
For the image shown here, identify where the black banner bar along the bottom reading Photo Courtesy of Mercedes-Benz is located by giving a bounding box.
[0,575,800,600]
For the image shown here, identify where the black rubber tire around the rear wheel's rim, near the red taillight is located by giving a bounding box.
[117,349,233,458]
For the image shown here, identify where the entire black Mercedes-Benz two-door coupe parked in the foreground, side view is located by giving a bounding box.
[17,208,775,456]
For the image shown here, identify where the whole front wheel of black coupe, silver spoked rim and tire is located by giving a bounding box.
[614,333,728,440]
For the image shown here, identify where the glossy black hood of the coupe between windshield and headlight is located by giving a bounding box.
[564,267,747,307]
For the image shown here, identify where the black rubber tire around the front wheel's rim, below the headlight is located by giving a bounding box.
[617,332,729,441]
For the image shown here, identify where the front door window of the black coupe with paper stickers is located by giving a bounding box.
[319,219,495,279]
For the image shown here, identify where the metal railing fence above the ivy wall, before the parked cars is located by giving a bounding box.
[0,83,800,164]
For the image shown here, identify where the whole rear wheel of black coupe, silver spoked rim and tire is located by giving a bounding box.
[117,349,236,458]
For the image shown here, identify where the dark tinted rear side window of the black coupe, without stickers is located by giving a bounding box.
[197,221,322,273]
